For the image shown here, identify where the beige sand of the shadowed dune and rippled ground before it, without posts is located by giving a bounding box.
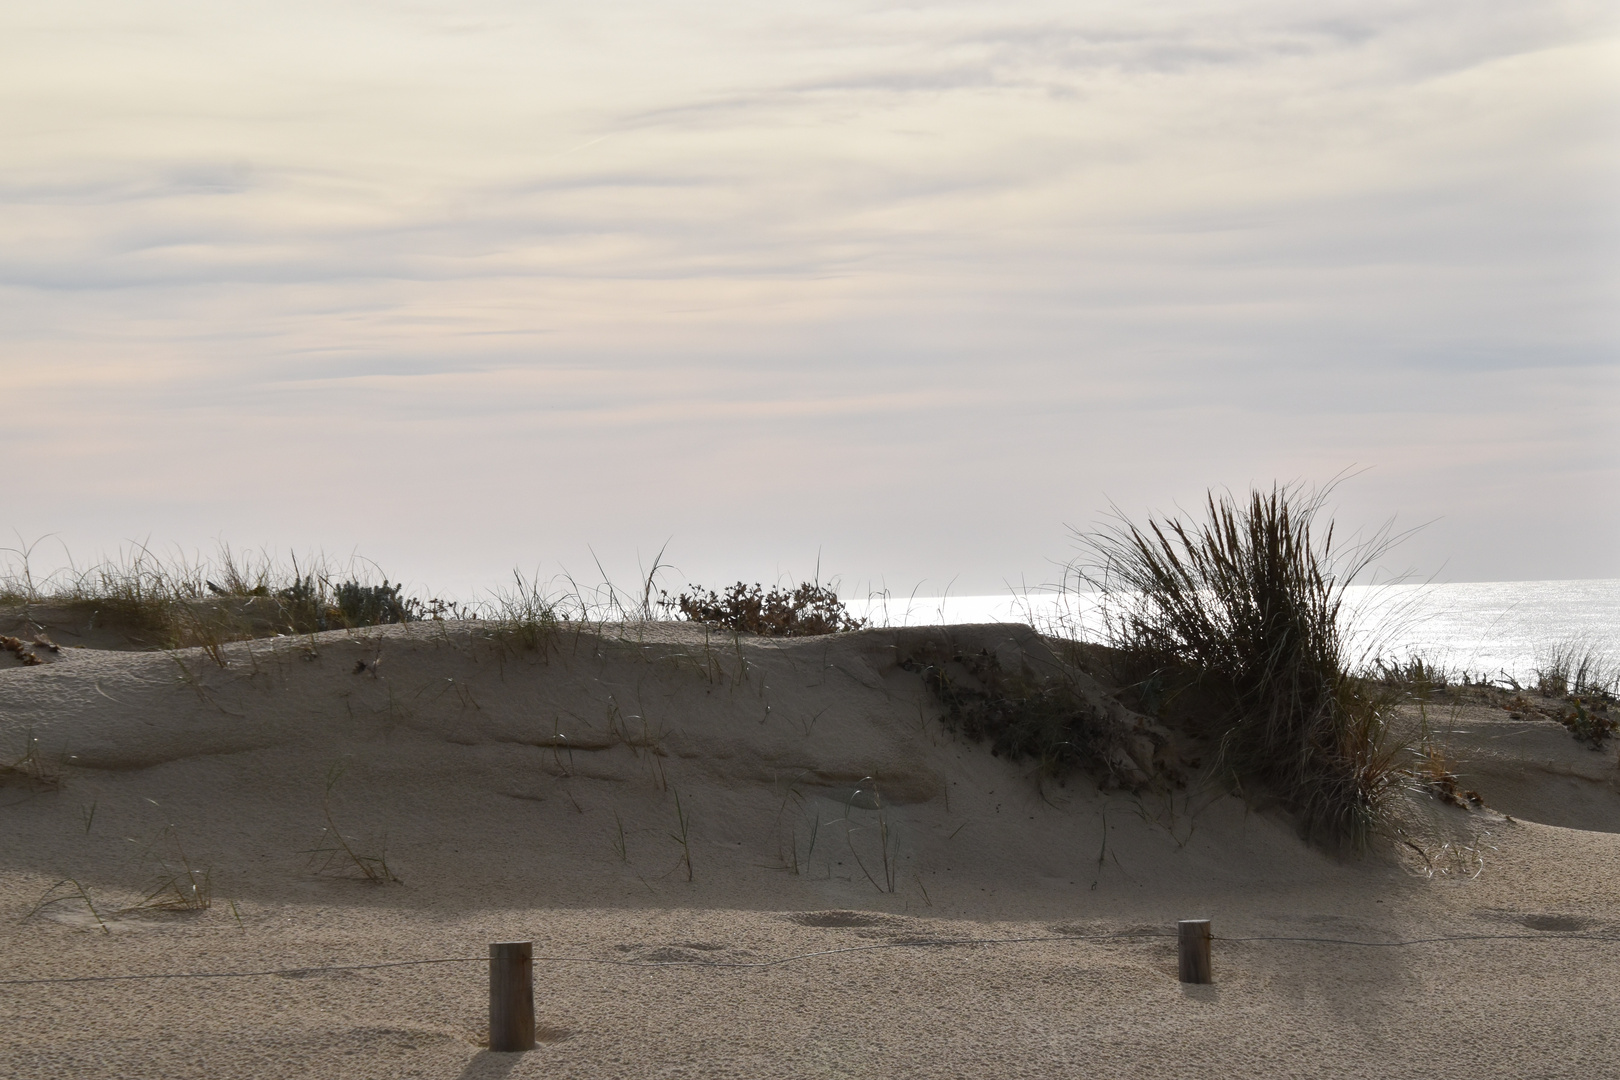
[0,623,1620,1078]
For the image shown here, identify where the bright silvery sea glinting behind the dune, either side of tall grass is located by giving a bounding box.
[851,580,1620,682]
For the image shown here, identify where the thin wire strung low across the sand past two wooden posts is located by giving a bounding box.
[0,933,1620,986]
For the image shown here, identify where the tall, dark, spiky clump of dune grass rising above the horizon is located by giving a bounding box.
[1079,486,1405,848]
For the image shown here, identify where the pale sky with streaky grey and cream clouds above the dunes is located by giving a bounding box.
[0,0,1620,596]
